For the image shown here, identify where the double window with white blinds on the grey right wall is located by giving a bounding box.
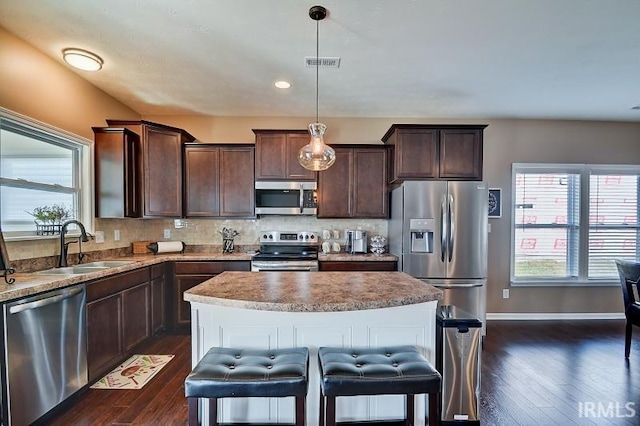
[511,164,640,285]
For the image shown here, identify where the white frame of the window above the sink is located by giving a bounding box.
[0,107,95,241]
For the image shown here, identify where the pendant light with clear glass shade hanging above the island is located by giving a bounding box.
[298,6,336,172]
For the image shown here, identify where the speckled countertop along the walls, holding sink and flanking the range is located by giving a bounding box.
[0,251,397,302]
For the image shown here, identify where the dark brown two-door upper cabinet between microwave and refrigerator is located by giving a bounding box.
[318,145,389,219]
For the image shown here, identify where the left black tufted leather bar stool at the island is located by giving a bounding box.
[184,347,309,426]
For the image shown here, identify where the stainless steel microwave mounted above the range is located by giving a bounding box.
[256,181,318,215]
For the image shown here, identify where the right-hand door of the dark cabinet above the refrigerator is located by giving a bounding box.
[440,129,482,180]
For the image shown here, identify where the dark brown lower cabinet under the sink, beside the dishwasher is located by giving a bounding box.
[87,268,151,382]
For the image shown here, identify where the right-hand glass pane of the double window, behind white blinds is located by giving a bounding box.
[588,174,639,278]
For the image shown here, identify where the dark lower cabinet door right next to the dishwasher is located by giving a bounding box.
[87,293,124,382]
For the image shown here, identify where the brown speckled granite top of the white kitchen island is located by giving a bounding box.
[184,271,442,312]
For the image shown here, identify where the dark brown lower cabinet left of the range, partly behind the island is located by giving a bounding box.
[171,260,251,333]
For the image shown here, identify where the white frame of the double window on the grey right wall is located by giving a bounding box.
[509,163,640,287]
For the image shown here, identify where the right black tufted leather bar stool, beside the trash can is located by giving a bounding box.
[318,346,442,426]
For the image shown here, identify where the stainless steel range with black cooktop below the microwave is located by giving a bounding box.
[251,231,318,271]
